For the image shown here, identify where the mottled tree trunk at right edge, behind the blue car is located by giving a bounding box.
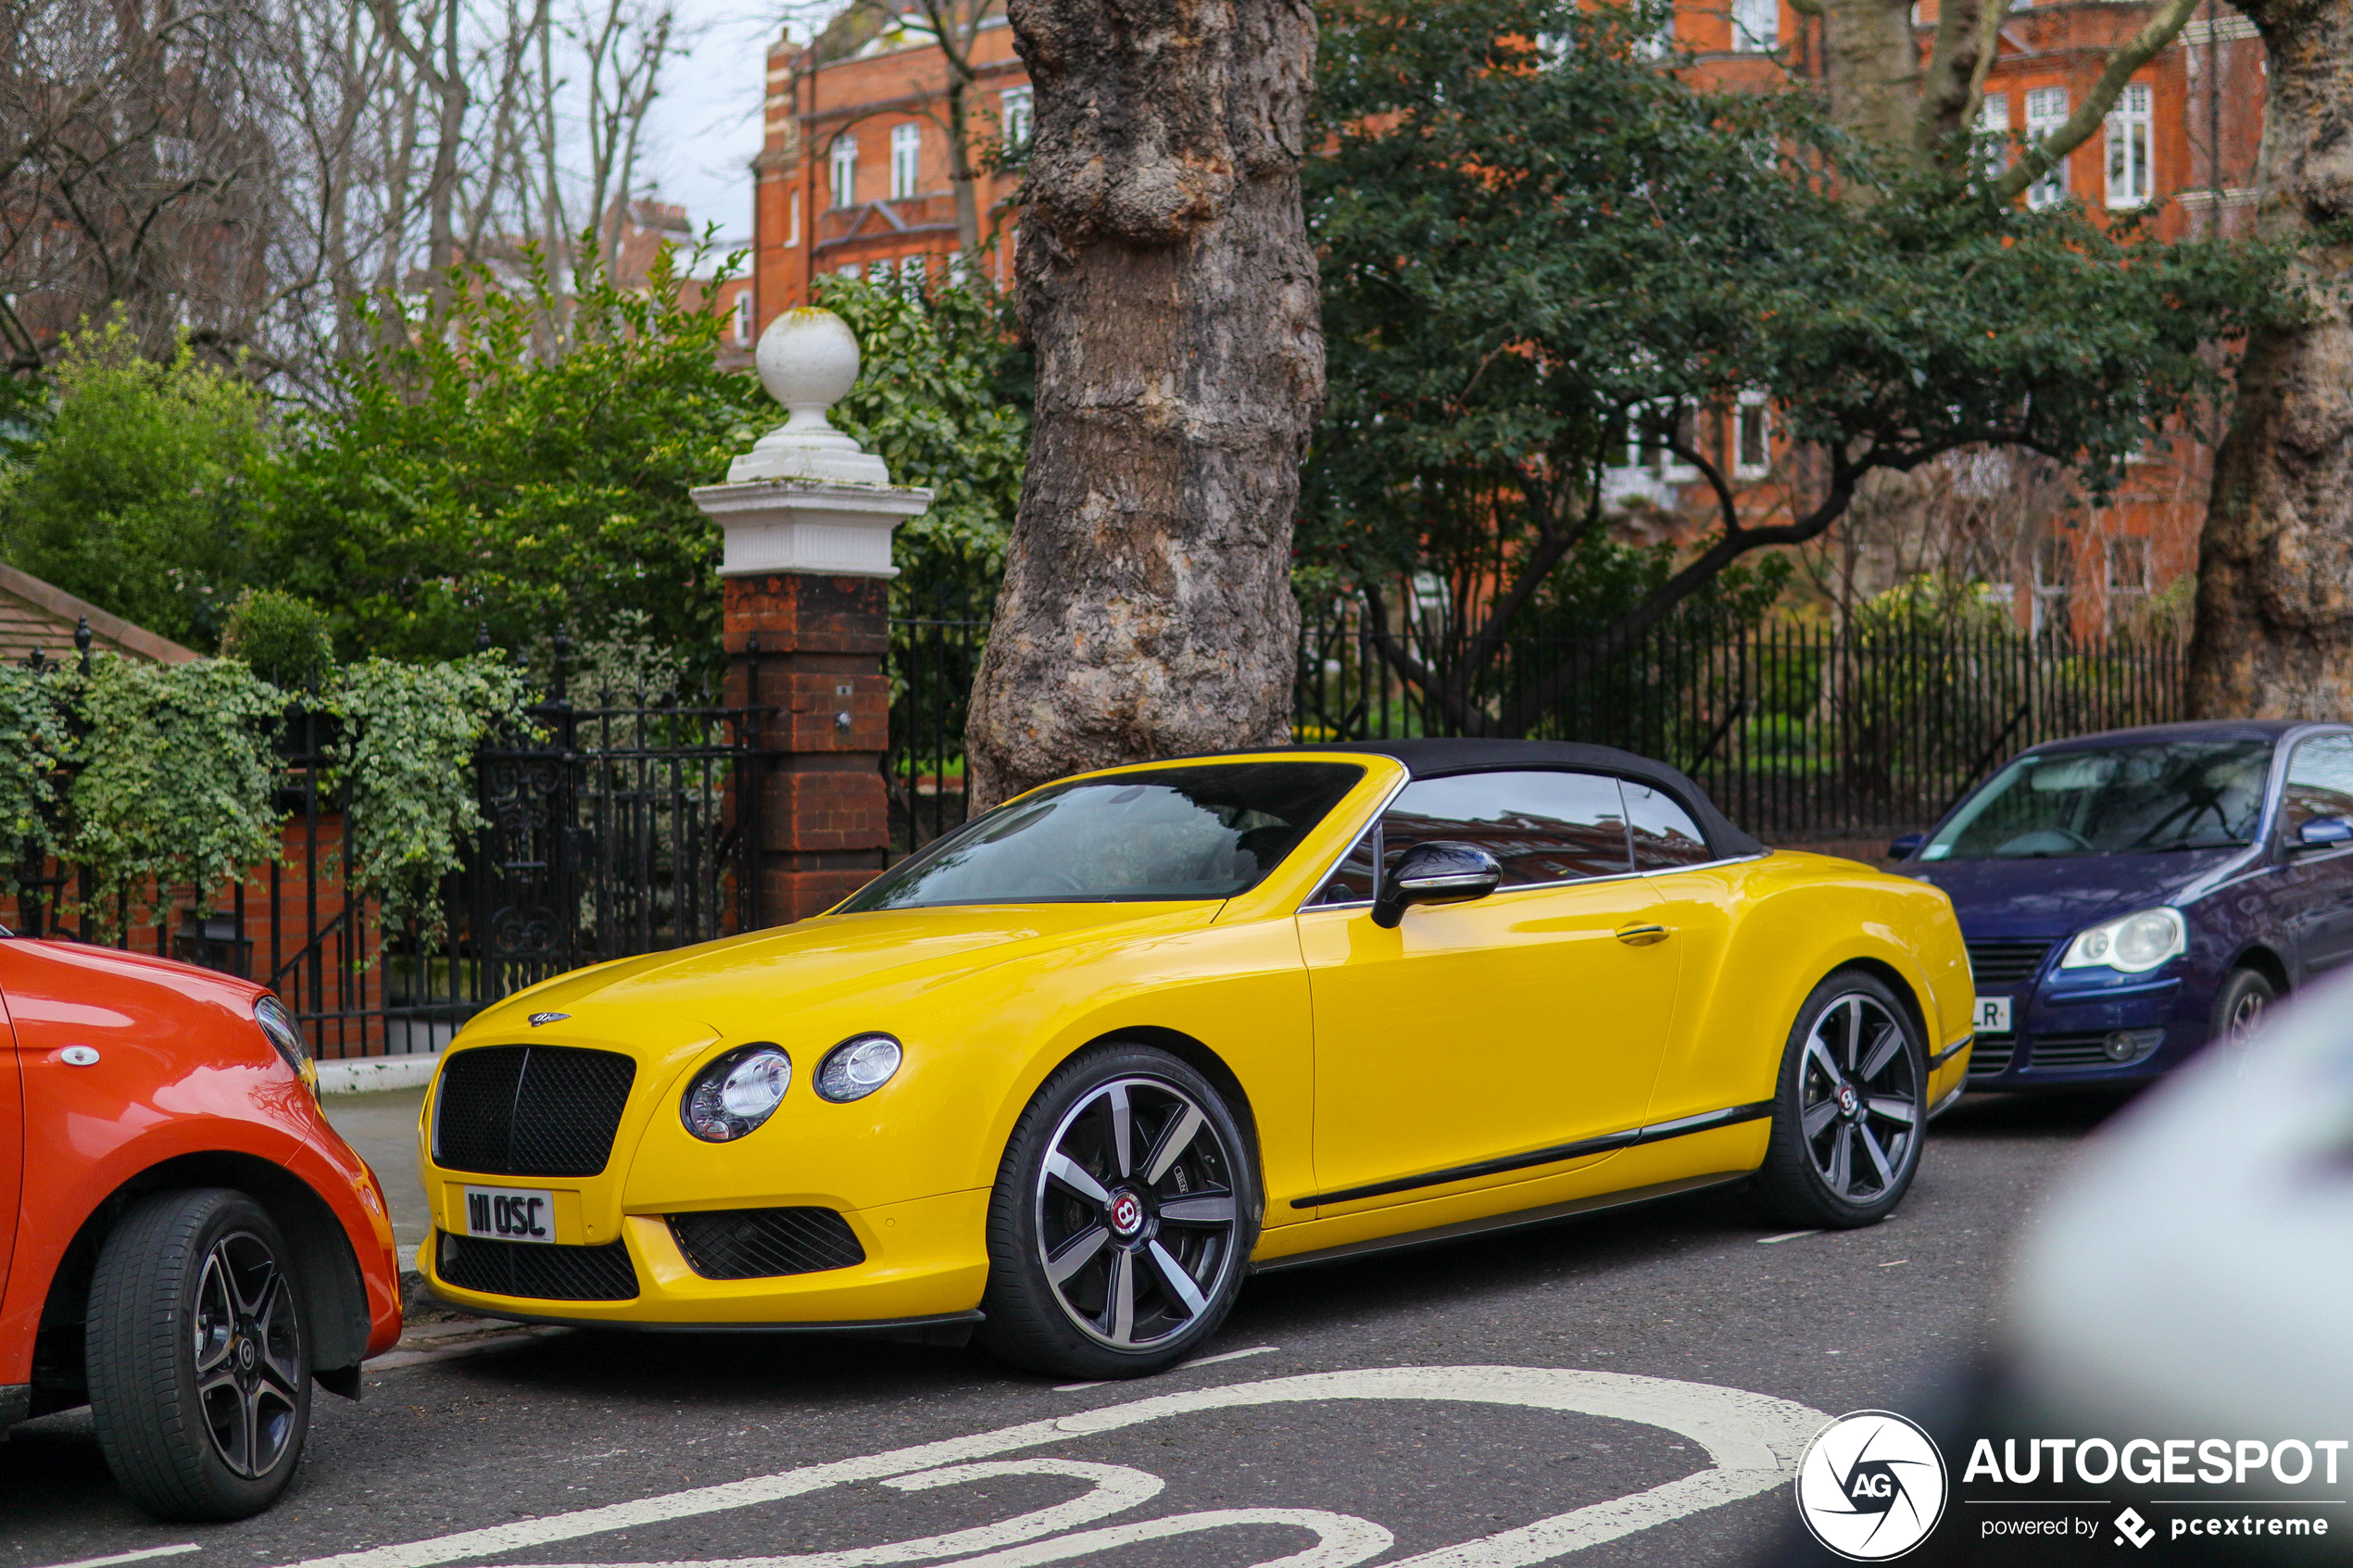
[2191,0,2353,720]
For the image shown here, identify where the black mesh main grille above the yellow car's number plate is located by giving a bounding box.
[433,1047,637,1175]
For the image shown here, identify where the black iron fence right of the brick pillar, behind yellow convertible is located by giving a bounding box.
[887,602,2183,853]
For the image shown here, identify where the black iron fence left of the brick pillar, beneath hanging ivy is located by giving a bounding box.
[9,691,765,1060]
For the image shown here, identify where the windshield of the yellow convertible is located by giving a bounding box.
[842,761,1365,914]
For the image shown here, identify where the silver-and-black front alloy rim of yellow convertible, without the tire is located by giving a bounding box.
[1036,1077,1242,1349]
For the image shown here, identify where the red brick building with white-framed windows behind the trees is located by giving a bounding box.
[744,0,2263,634]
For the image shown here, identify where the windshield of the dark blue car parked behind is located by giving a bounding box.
[1920,741,2271,860]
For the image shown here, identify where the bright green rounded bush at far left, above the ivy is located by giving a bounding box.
[0,320,271,649]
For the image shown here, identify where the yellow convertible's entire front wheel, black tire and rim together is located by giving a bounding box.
[979,1044,1261,1377]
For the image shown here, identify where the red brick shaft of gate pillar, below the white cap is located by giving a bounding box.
[724,571,889,926]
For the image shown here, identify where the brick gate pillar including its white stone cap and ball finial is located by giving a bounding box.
[692,310,932,926]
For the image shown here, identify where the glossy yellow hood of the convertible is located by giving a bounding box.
[466,903,1221,1044]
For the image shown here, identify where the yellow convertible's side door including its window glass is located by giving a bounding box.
[1299,771,1678,1204]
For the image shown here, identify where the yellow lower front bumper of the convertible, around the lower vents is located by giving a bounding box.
[417,1178,988,1333]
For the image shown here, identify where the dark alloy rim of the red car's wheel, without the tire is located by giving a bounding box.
[193,1229,301,1481]
